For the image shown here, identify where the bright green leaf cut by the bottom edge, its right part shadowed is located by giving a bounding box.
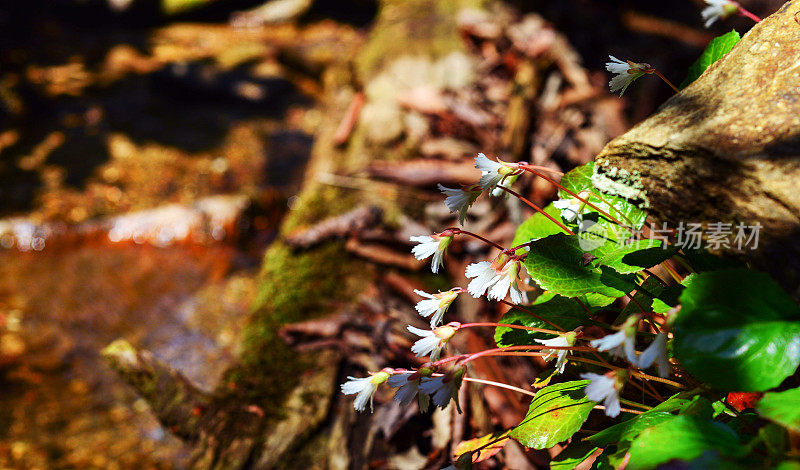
[627,415,746,470]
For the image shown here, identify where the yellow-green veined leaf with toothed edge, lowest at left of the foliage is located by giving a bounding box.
[509,380,595,449]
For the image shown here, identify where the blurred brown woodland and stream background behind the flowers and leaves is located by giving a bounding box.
[0,0,782,469]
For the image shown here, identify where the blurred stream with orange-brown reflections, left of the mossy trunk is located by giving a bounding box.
[0,5,313,469]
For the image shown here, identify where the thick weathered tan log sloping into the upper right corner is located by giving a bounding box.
[594,0,800,295]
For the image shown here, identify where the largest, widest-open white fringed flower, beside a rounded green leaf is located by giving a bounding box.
[466,254,522,304]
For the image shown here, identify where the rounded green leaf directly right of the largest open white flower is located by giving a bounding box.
[525,233,635,297]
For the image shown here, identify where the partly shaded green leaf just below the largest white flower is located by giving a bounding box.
[494,295,587,347]
